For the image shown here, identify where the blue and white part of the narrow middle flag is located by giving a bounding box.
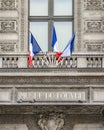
[52,26,59,52]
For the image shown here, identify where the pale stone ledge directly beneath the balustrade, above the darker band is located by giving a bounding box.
[0,68,104,77]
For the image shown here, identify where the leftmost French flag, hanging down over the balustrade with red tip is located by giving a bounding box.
[29,32,42,67]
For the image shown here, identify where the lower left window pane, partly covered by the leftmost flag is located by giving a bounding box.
[30,22,48,52]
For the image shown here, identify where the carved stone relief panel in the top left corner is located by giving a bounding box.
[0,0,17,10]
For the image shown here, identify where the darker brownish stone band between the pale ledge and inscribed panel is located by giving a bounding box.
[0,75,104,85]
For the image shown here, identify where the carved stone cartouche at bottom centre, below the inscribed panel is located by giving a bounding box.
[38,114,64,130]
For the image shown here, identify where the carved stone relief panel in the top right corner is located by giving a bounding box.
[84,0,104,10]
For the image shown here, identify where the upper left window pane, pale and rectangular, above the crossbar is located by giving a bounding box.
[30,0,48,16]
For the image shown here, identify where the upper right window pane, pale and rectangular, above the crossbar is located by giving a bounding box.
[54,0,72,15]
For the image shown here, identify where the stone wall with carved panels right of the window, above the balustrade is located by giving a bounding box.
[74,0,104,55]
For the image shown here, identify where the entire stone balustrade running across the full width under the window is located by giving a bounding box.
[0,53,104,69]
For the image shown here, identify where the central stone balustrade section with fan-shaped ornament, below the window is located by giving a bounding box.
[33,53,77,68]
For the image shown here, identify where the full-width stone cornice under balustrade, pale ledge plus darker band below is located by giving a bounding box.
[0,69,104,85]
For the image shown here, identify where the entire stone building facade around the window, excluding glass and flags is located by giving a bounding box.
[0,0,104,130]
